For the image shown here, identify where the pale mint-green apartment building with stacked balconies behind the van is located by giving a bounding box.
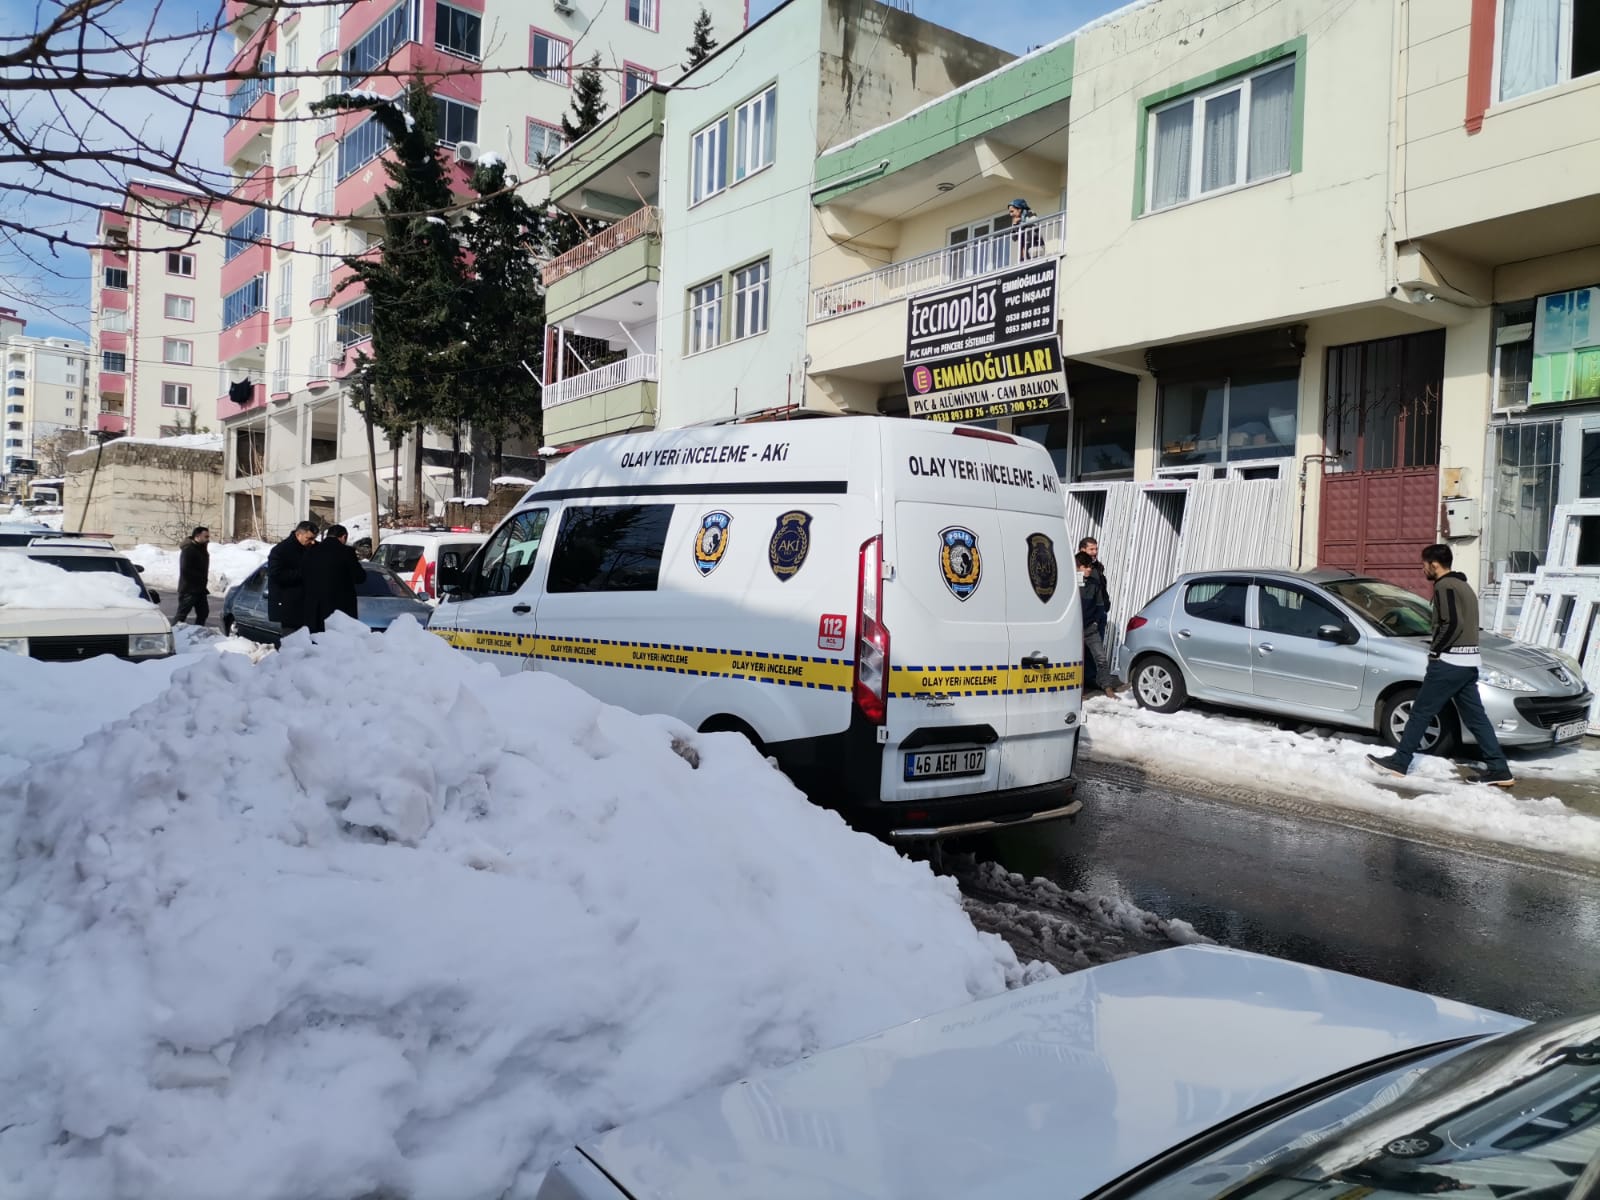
[542,0,1011,448]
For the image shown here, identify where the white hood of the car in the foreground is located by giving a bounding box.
[563,946,1523,1200]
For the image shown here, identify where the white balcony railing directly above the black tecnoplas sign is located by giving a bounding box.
[811,213,1067,322]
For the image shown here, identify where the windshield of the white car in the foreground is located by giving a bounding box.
[1126,1016,1600,1200]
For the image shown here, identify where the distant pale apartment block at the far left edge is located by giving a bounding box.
[0,309,90,488]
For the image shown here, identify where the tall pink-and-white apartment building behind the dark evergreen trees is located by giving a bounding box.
[214,0,746,534]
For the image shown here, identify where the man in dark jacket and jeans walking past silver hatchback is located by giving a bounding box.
[1366,544,1515,787]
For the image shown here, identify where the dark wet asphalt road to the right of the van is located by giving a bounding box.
[963,768,1600,1018]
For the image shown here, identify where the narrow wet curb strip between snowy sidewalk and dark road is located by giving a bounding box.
[1075,757,1600,880]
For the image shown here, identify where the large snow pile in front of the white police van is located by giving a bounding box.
[0,618,1040,1200]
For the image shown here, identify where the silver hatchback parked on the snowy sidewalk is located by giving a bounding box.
[1117,570,1592,754]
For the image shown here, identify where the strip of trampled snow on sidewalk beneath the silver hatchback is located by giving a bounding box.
[1083,696,1600,861]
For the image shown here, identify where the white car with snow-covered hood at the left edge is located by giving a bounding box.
[0,541,173,662]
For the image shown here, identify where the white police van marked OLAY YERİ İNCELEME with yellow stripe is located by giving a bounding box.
[429,418,1083,838]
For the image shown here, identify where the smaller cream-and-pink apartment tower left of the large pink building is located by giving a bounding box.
[90,181,222,438]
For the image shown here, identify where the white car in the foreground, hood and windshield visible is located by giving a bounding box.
[538,946,1600,1200]
